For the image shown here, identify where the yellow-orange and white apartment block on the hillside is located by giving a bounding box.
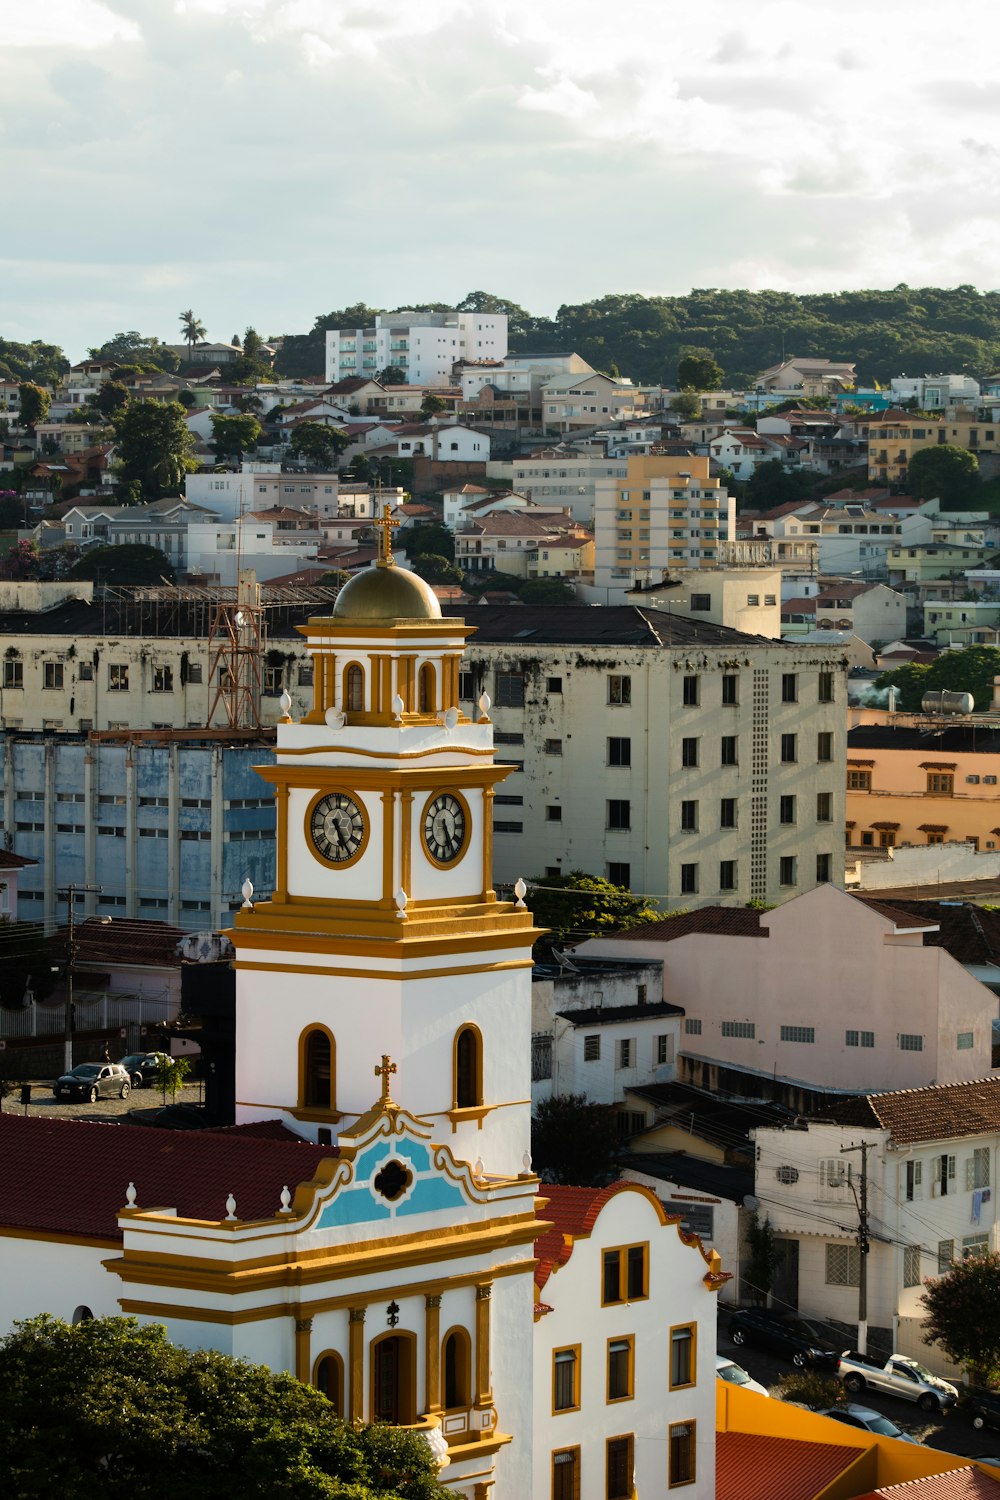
[594,453,736,590]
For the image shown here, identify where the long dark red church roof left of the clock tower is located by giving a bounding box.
[0,1115,336,1242]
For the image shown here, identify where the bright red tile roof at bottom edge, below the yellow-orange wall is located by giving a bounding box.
[715,1433,864,1500]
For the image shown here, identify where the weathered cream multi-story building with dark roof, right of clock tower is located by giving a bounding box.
[462,605,847,908]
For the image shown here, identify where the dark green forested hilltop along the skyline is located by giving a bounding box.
[277,287,1000,389]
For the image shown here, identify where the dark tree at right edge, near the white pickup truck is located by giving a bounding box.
[921,1250,1000,1386]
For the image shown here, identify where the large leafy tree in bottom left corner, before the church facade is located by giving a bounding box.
[0,1317,451,1500]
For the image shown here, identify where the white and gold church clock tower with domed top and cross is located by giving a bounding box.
[231,519,537,1175]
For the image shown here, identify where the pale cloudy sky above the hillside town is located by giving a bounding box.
[0,0,1000,359]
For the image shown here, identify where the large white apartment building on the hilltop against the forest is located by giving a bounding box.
[327,309,507,386]
